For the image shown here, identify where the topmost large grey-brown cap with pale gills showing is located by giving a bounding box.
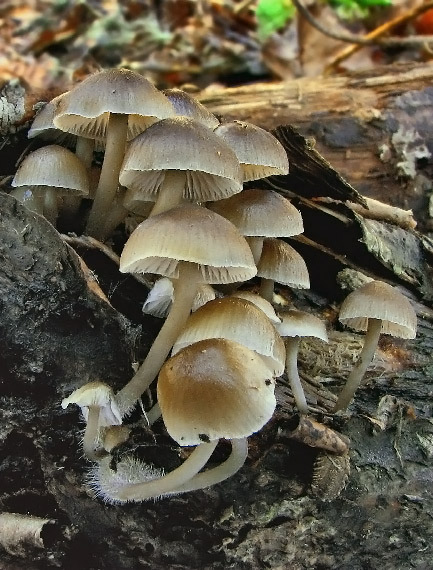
[54,69,174,139]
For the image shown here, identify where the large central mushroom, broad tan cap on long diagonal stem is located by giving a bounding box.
[117,204,256,414]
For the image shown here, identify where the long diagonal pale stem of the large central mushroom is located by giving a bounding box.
[116,261,202,416]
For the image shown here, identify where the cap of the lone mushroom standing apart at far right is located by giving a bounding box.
[339,281,417,338]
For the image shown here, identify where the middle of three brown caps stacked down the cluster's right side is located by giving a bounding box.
[210,188,304,237]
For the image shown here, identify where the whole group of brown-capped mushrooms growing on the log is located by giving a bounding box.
[19,69,415,502]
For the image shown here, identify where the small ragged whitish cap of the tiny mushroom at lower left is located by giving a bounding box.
[62,381,122,426]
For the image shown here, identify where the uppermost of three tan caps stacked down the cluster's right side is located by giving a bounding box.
[215,121,289,182]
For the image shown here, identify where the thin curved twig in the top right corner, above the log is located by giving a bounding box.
[293,0,433,47]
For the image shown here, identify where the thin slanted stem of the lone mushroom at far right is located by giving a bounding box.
[333,319,382,412]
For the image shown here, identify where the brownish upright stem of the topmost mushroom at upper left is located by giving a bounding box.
[86,113,128,240]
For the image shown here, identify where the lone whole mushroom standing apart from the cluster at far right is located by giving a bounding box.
[333,281,417,412]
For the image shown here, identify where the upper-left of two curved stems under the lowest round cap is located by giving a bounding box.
[118,440,218,501]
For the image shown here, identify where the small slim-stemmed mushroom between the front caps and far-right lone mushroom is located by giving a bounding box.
[275,309,328,414]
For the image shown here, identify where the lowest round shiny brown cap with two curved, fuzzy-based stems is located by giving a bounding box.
[92,339,276,503]
